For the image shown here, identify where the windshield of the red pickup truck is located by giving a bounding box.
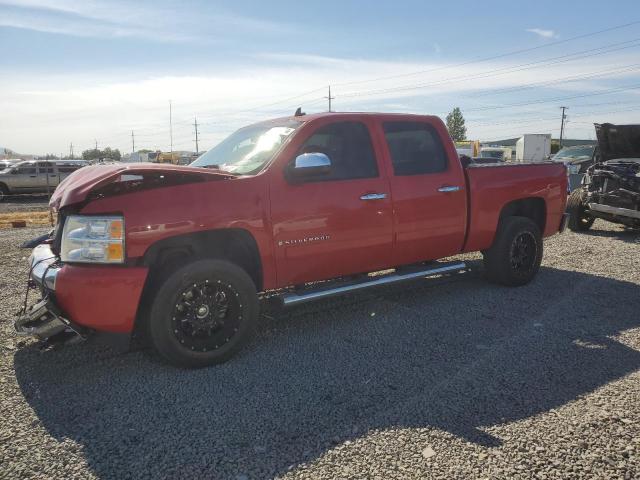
[190,120,301,175]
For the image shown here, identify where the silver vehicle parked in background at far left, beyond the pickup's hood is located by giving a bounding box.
[0,160,88,202]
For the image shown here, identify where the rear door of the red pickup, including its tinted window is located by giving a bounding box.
[381,120,467,265]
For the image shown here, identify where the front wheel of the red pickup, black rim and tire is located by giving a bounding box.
[148,259,258,368]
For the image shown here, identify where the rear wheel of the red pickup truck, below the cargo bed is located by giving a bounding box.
[482,216,543,287]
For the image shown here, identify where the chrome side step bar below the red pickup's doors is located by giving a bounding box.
[280,262,467,307]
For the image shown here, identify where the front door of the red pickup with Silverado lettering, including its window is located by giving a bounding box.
[270,119,392,286]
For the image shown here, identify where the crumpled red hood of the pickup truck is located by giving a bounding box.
[49,163,233,209]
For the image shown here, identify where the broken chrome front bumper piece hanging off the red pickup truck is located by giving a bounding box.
[14,244,89,340]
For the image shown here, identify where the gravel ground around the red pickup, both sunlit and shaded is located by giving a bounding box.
[0,222,640,480]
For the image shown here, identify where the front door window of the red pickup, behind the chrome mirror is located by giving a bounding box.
[296,122,378,181]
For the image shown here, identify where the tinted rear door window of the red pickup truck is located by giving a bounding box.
[383,122,447,176]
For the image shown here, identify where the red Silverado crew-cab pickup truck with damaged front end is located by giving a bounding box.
[15,113,567,367]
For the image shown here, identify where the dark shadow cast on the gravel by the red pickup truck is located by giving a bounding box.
[15,268,640,478]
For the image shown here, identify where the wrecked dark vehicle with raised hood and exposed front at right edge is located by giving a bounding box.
[567,123,640,232]
